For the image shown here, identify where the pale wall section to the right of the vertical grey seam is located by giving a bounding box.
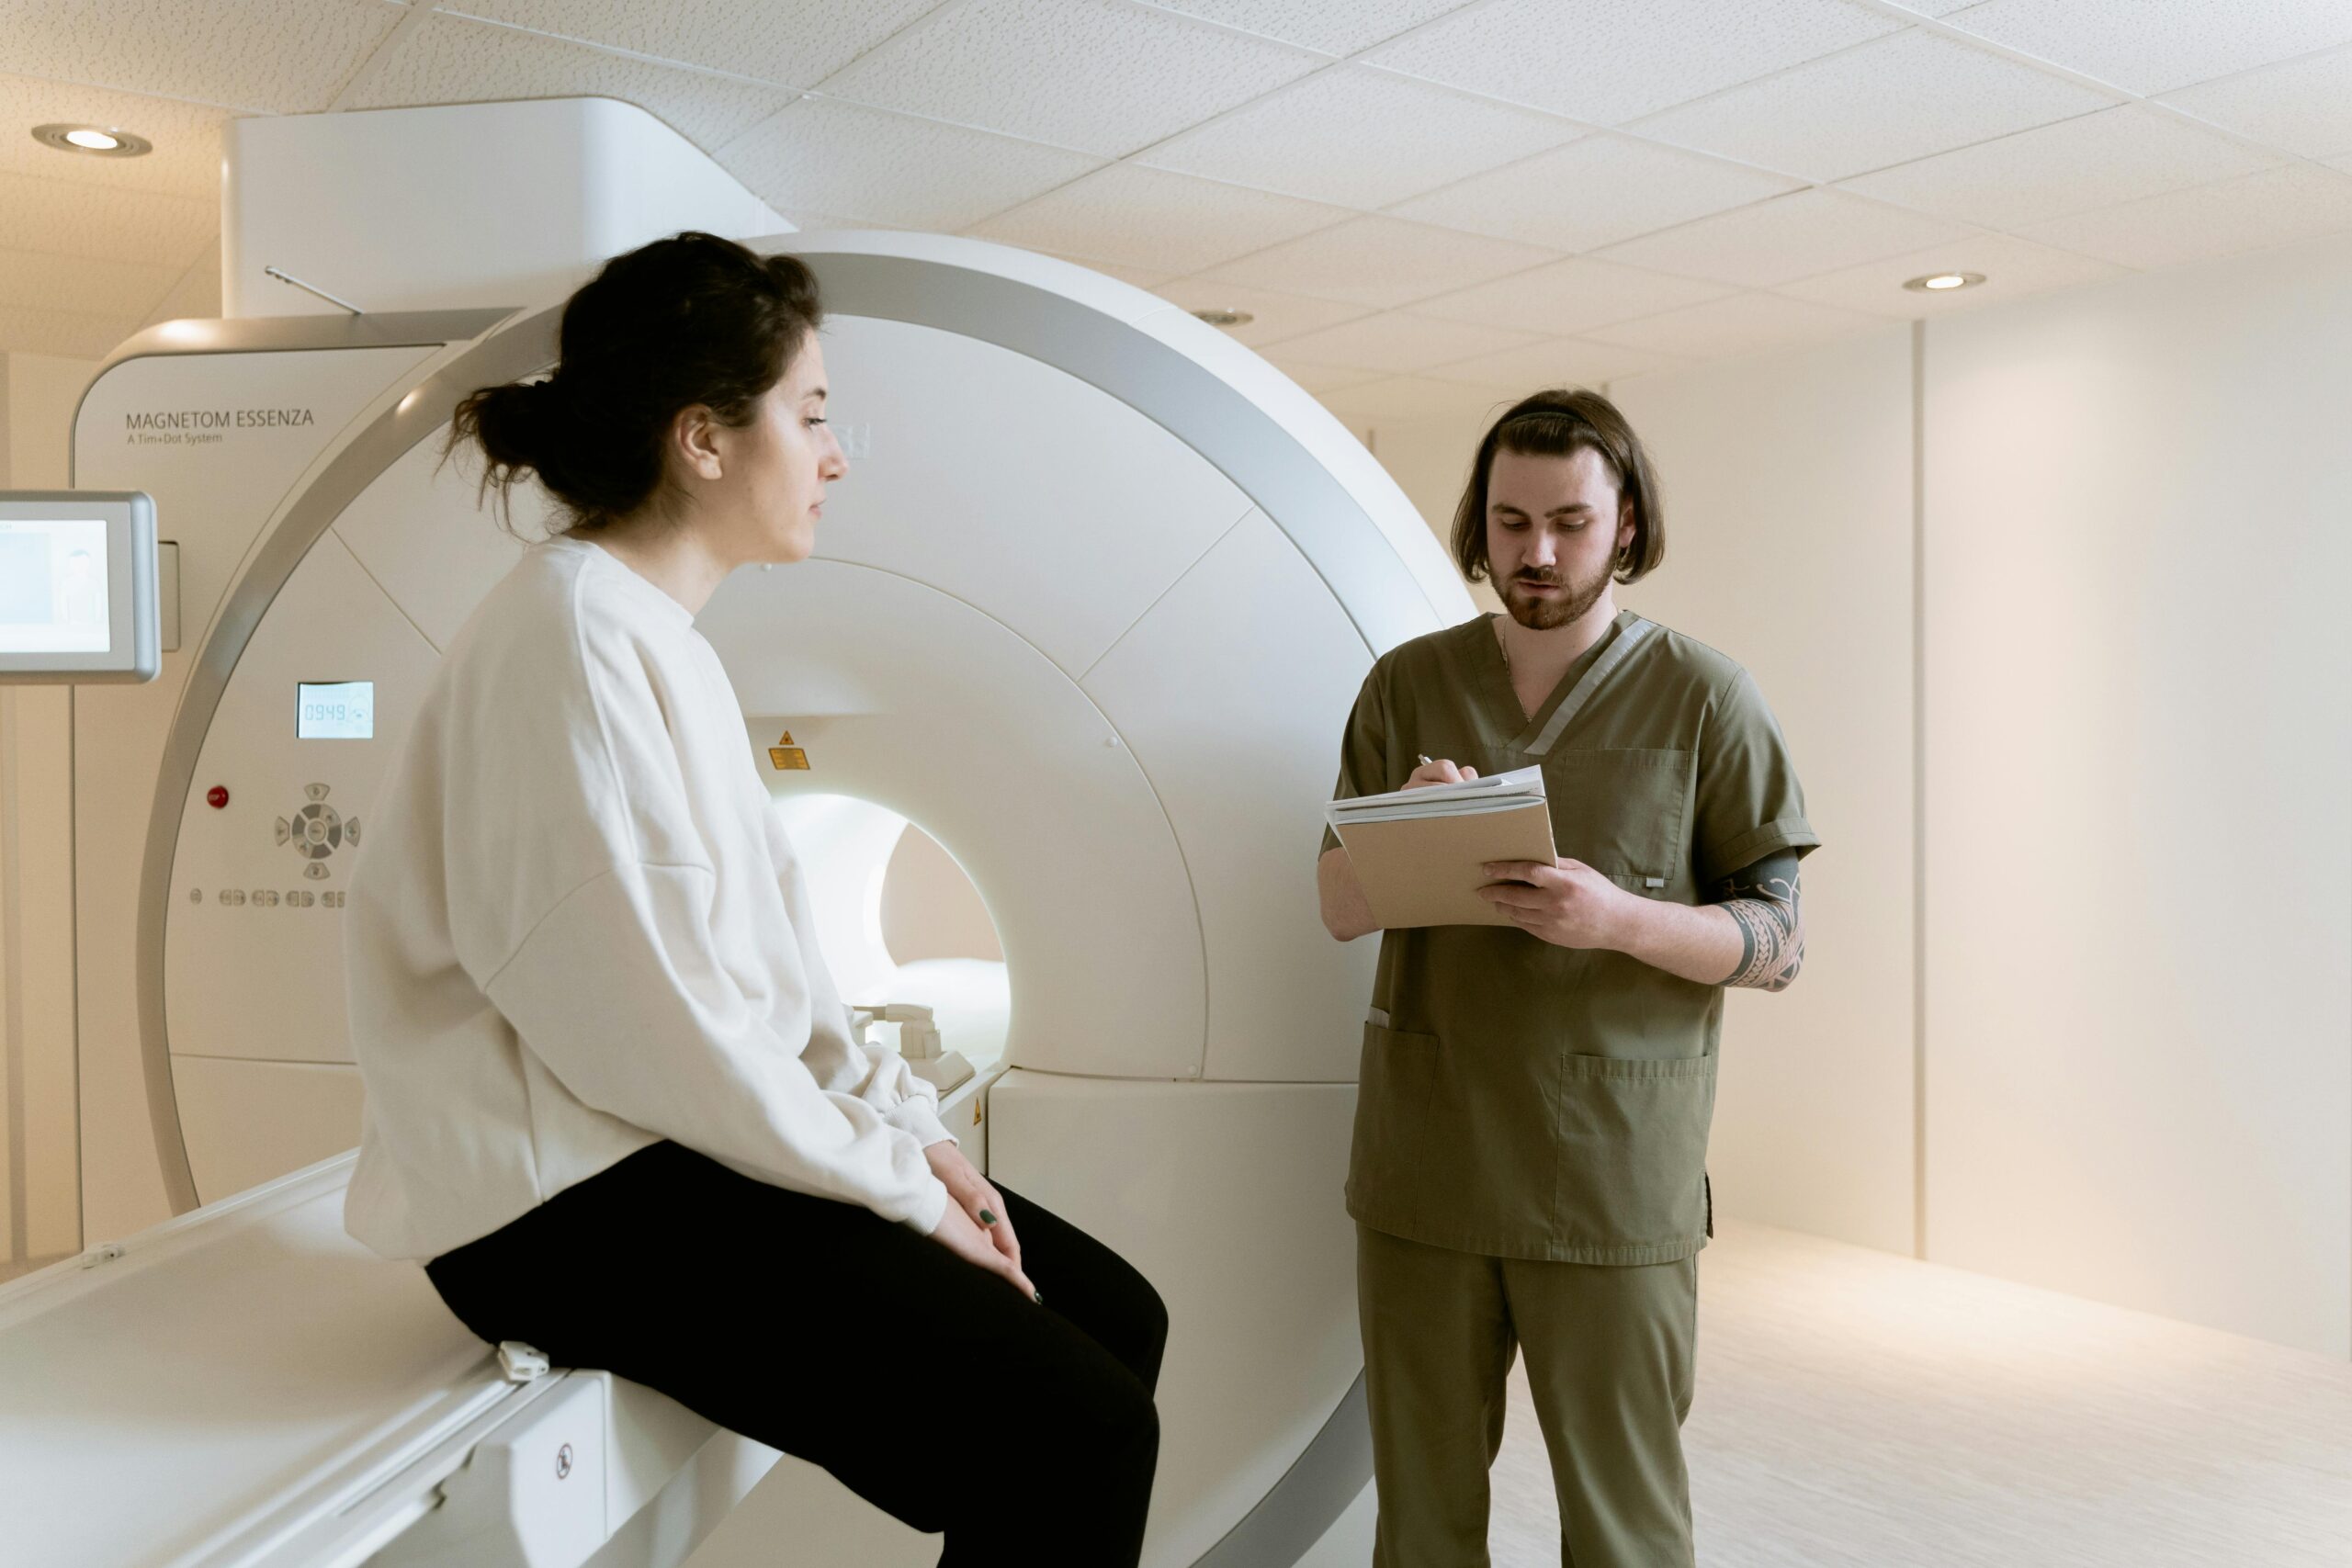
[1924,240,2352,1357]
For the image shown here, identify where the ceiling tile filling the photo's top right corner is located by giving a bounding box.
[1945,0,2352,94]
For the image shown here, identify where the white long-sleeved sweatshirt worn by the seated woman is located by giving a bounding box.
[344,538,948,1258]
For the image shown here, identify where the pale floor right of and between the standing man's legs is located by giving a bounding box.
[1491,1224,2352,1568]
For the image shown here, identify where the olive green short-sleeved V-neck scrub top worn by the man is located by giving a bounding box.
[1324,611,1820,1265]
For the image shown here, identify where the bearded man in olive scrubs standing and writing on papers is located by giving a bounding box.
[1317,390,1820,1568]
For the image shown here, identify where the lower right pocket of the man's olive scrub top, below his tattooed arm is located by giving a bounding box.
[1553,1054,1717,1262]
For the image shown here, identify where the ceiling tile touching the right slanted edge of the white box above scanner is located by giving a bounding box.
[718,98,1099,231]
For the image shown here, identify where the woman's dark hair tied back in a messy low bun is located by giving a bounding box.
[442,232,823,531]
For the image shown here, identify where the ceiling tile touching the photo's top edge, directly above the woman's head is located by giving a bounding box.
[442,0,941,87]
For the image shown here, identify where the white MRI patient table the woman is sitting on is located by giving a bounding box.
[0,1155,774,1568]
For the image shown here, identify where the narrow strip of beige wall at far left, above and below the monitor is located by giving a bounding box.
[0,355,96,1267]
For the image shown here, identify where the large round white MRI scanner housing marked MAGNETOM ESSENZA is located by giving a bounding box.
[28,232,1470,1565]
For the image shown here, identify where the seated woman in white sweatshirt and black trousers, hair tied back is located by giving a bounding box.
[345,232,1167,1568]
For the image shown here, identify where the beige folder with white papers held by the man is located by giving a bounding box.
[1324,769,1557,929]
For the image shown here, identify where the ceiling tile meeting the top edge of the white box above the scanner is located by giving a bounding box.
[348,17,793,148]
